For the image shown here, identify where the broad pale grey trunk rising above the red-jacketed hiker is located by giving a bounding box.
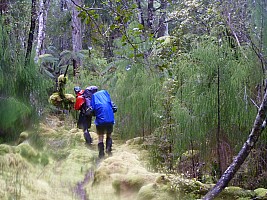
[72,0,82,76]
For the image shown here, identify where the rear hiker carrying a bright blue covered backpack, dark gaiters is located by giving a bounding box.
[91,90,117,158]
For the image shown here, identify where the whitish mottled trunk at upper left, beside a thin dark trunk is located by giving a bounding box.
[34,0,50,63]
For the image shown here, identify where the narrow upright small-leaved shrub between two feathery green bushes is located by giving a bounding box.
[148,79,178,171]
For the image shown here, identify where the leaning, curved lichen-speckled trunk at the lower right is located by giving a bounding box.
[203,88,267,200]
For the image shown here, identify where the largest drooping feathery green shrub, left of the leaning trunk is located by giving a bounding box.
[144,32,262,181]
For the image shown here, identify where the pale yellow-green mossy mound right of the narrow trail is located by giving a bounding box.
[76,138,176,200]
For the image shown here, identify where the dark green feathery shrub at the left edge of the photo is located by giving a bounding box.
[0,17,49,141]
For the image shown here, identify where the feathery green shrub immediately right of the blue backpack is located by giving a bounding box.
[111,64,160,138]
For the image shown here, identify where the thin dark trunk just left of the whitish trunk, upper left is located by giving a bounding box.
[25,0,36,65]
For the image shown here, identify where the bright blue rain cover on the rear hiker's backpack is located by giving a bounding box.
[91,90,115,126]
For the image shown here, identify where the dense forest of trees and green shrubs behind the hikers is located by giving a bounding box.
[0,0,267,197]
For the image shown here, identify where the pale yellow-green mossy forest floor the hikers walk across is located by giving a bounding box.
[0,113,266,200]
